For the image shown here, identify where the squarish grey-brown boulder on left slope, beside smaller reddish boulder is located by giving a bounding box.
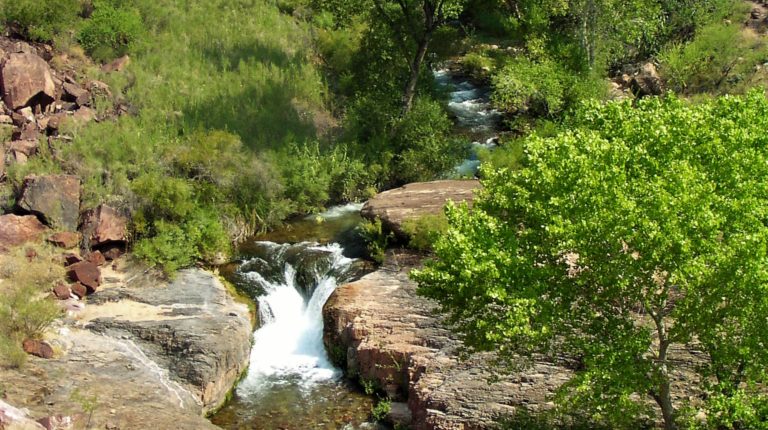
[18,175,80,231]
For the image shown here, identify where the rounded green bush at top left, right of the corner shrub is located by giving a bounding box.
[78,1,145,61]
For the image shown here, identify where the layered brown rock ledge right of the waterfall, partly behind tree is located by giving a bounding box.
[323,255,571,430]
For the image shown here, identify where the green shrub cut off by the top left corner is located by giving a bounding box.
[0,0,82,42]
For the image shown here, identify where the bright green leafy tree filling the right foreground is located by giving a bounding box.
[413,92,768,428]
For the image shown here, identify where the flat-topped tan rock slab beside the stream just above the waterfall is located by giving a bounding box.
[361,180,480,238]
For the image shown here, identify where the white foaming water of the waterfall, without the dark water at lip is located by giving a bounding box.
[237,243,353,395]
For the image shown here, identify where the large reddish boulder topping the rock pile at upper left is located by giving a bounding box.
[0,52,56,110]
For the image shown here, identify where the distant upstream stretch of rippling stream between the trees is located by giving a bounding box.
[434,68,502,176]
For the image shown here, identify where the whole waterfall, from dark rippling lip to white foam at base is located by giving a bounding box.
[237,242,355,396]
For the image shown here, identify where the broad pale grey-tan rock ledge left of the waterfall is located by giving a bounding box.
[0,261,252,429]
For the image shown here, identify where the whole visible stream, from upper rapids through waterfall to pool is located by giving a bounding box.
[211,65,501,430]
